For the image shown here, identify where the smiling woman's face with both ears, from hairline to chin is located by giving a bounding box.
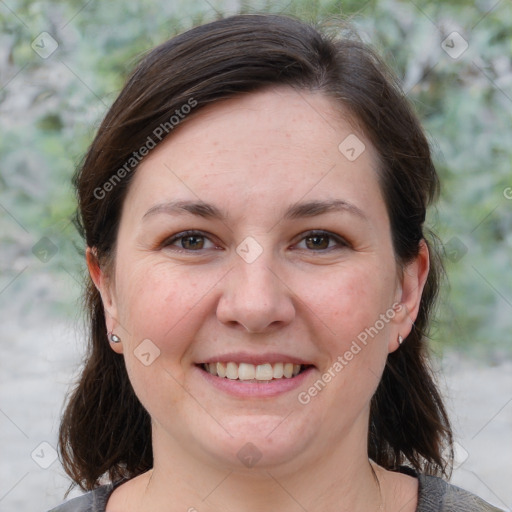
[90,88,428,474]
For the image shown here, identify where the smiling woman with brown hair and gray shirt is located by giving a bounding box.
[50,15,497,512]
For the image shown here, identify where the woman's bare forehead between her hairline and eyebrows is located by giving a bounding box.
[126,88,384,222]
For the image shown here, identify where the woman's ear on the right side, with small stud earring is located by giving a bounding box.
[388,240,430,352]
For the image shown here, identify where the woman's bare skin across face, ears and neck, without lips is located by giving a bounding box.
[87,88,428,512]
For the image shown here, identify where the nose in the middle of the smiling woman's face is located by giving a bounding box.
[217,251,295,333]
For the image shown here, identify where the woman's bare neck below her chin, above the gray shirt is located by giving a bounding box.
[139,422,382,512]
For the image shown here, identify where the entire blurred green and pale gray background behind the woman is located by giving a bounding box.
[0,0,512,511]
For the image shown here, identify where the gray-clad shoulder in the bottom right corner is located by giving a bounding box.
[417,475,501,512]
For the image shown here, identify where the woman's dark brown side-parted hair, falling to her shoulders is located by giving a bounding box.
[59,15,452,490]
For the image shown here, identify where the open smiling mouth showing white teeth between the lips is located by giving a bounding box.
[197,361,312,383]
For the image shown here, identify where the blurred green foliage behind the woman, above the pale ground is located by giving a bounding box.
[0,0,512,359]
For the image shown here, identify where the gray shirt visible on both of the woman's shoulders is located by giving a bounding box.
[49,475,502,512]
